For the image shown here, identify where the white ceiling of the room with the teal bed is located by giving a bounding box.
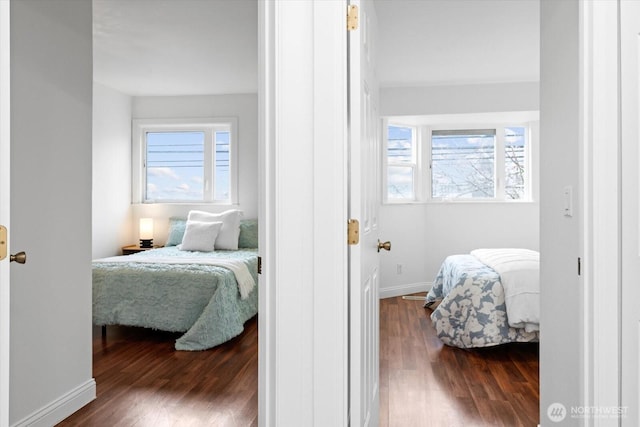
[93,0,258,95]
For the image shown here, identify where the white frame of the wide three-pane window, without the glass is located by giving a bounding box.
[382,114,538,205]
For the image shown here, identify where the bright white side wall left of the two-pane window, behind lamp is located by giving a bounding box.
[92,83,135,259]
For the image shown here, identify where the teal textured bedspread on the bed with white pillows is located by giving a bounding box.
[93,247,258,350]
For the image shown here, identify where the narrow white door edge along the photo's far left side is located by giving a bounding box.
[0,1,11,427]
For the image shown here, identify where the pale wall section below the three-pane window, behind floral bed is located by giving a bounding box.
[380,203,539,297]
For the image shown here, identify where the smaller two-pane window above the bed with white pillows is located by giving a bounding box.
[133,119,236,204]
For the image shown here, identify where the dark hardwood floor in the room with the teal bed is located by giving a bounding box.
[58,317,258,427]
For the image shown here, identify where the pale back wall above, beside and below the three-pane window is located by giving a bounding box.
[380,83,539,297]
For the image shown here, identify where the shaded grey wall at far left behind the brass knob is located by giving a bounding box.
[10,0,95,426]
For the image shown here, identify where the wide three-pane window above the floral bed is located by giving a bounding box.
[384,117,531,203]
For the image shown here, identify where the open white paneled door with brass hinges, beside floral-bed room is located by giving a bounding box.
[349,0,380,426]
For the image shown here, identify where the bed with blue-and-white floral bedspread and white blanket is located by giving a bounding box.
[424,248,540,348]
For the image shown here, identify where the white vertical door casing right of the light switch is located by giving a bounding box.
[580,0,621,426]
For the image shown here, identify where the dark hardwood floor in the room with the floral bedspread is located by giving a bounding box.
[380,297,539,427]
